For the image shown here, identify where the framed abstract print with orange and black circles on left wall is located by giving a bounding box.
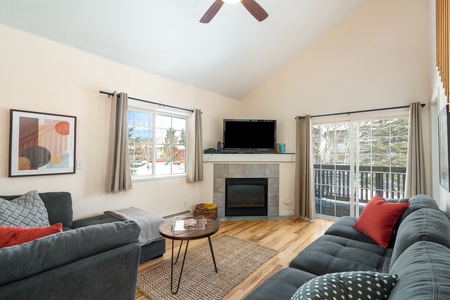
[8,109,77,177]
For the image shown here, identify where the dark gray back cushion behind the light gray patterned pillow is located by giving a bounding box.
[0,192,73,229]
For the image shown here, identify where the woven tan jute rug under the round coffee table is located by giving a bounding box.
[137,235,277,300]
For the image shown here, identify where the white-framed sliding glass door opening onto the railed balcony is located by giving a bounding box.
[312,116,408,217]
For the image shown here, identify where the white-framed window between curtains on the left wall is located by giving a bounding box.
[128,108,187,178]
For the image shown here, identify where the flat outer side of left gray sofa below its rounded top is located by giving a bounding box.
[0,243,140,300]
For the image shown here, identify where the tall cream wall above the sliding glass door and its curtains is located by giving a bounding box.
[242,0,434,210]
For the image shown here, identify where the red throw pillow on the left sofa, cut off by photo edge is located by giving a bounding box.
[0,223,62,248]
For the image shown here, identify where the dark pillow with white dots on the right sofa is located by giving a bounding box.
[291,271,397,300]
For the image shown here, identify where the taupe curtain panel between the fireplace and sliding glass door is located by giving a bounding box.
[294,115,316,221]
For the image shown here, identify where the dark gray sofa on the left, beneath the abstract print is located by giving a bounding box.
[0,192,165,300]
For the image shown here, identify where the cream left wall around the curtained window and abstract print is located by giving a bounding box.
[0,26,240,218]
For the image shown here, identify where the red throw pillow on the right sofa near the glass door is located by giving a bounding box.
[354,194,409,248]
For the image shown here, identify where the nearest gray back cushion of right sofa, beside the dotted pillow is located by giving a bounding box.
[389,241,450,300]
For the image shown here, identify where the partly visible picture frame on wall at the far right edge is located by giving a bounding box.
[438,104,450,191]
